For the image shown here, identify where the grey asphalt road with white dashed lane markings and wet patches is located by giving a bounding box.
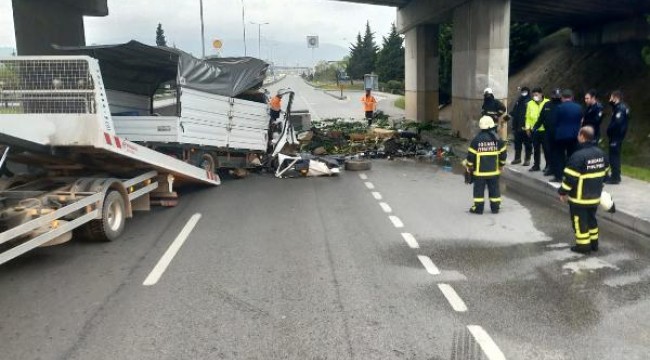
[0,76,650,360]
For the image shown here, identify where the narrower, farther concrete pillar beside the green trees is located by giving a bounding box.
[404,25,439,122]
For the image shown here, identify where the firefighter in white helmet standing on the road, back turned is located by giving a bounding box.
[464,115,507,215]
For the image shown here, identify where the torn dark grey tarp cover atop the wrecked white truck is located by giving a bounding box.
[55,40,269,97]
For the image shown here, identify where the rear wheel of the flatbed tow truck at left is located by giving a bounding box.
[87,190,126,242]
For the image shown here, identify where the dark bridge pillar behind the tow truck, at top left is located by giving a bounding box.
[12,0,108,55]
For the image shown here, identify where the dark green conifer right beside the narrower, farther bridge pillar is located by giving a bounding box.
[375,23,404,82]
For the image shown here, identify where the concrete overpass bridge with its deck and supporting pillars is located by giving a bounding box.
[12,0,650,137]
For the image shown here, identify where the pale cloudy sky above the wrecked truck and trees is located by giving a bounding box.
[0,0,395,65]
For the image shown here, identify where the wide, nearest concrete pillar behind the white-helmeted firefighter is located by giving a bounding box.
[451,0,510,138]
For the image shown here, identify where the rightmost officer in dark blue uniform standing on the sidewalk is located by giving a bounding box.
[606,90,630,185]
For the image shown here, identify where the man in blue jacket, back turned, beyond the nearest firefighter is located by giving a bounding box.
[552,89,582,182]
